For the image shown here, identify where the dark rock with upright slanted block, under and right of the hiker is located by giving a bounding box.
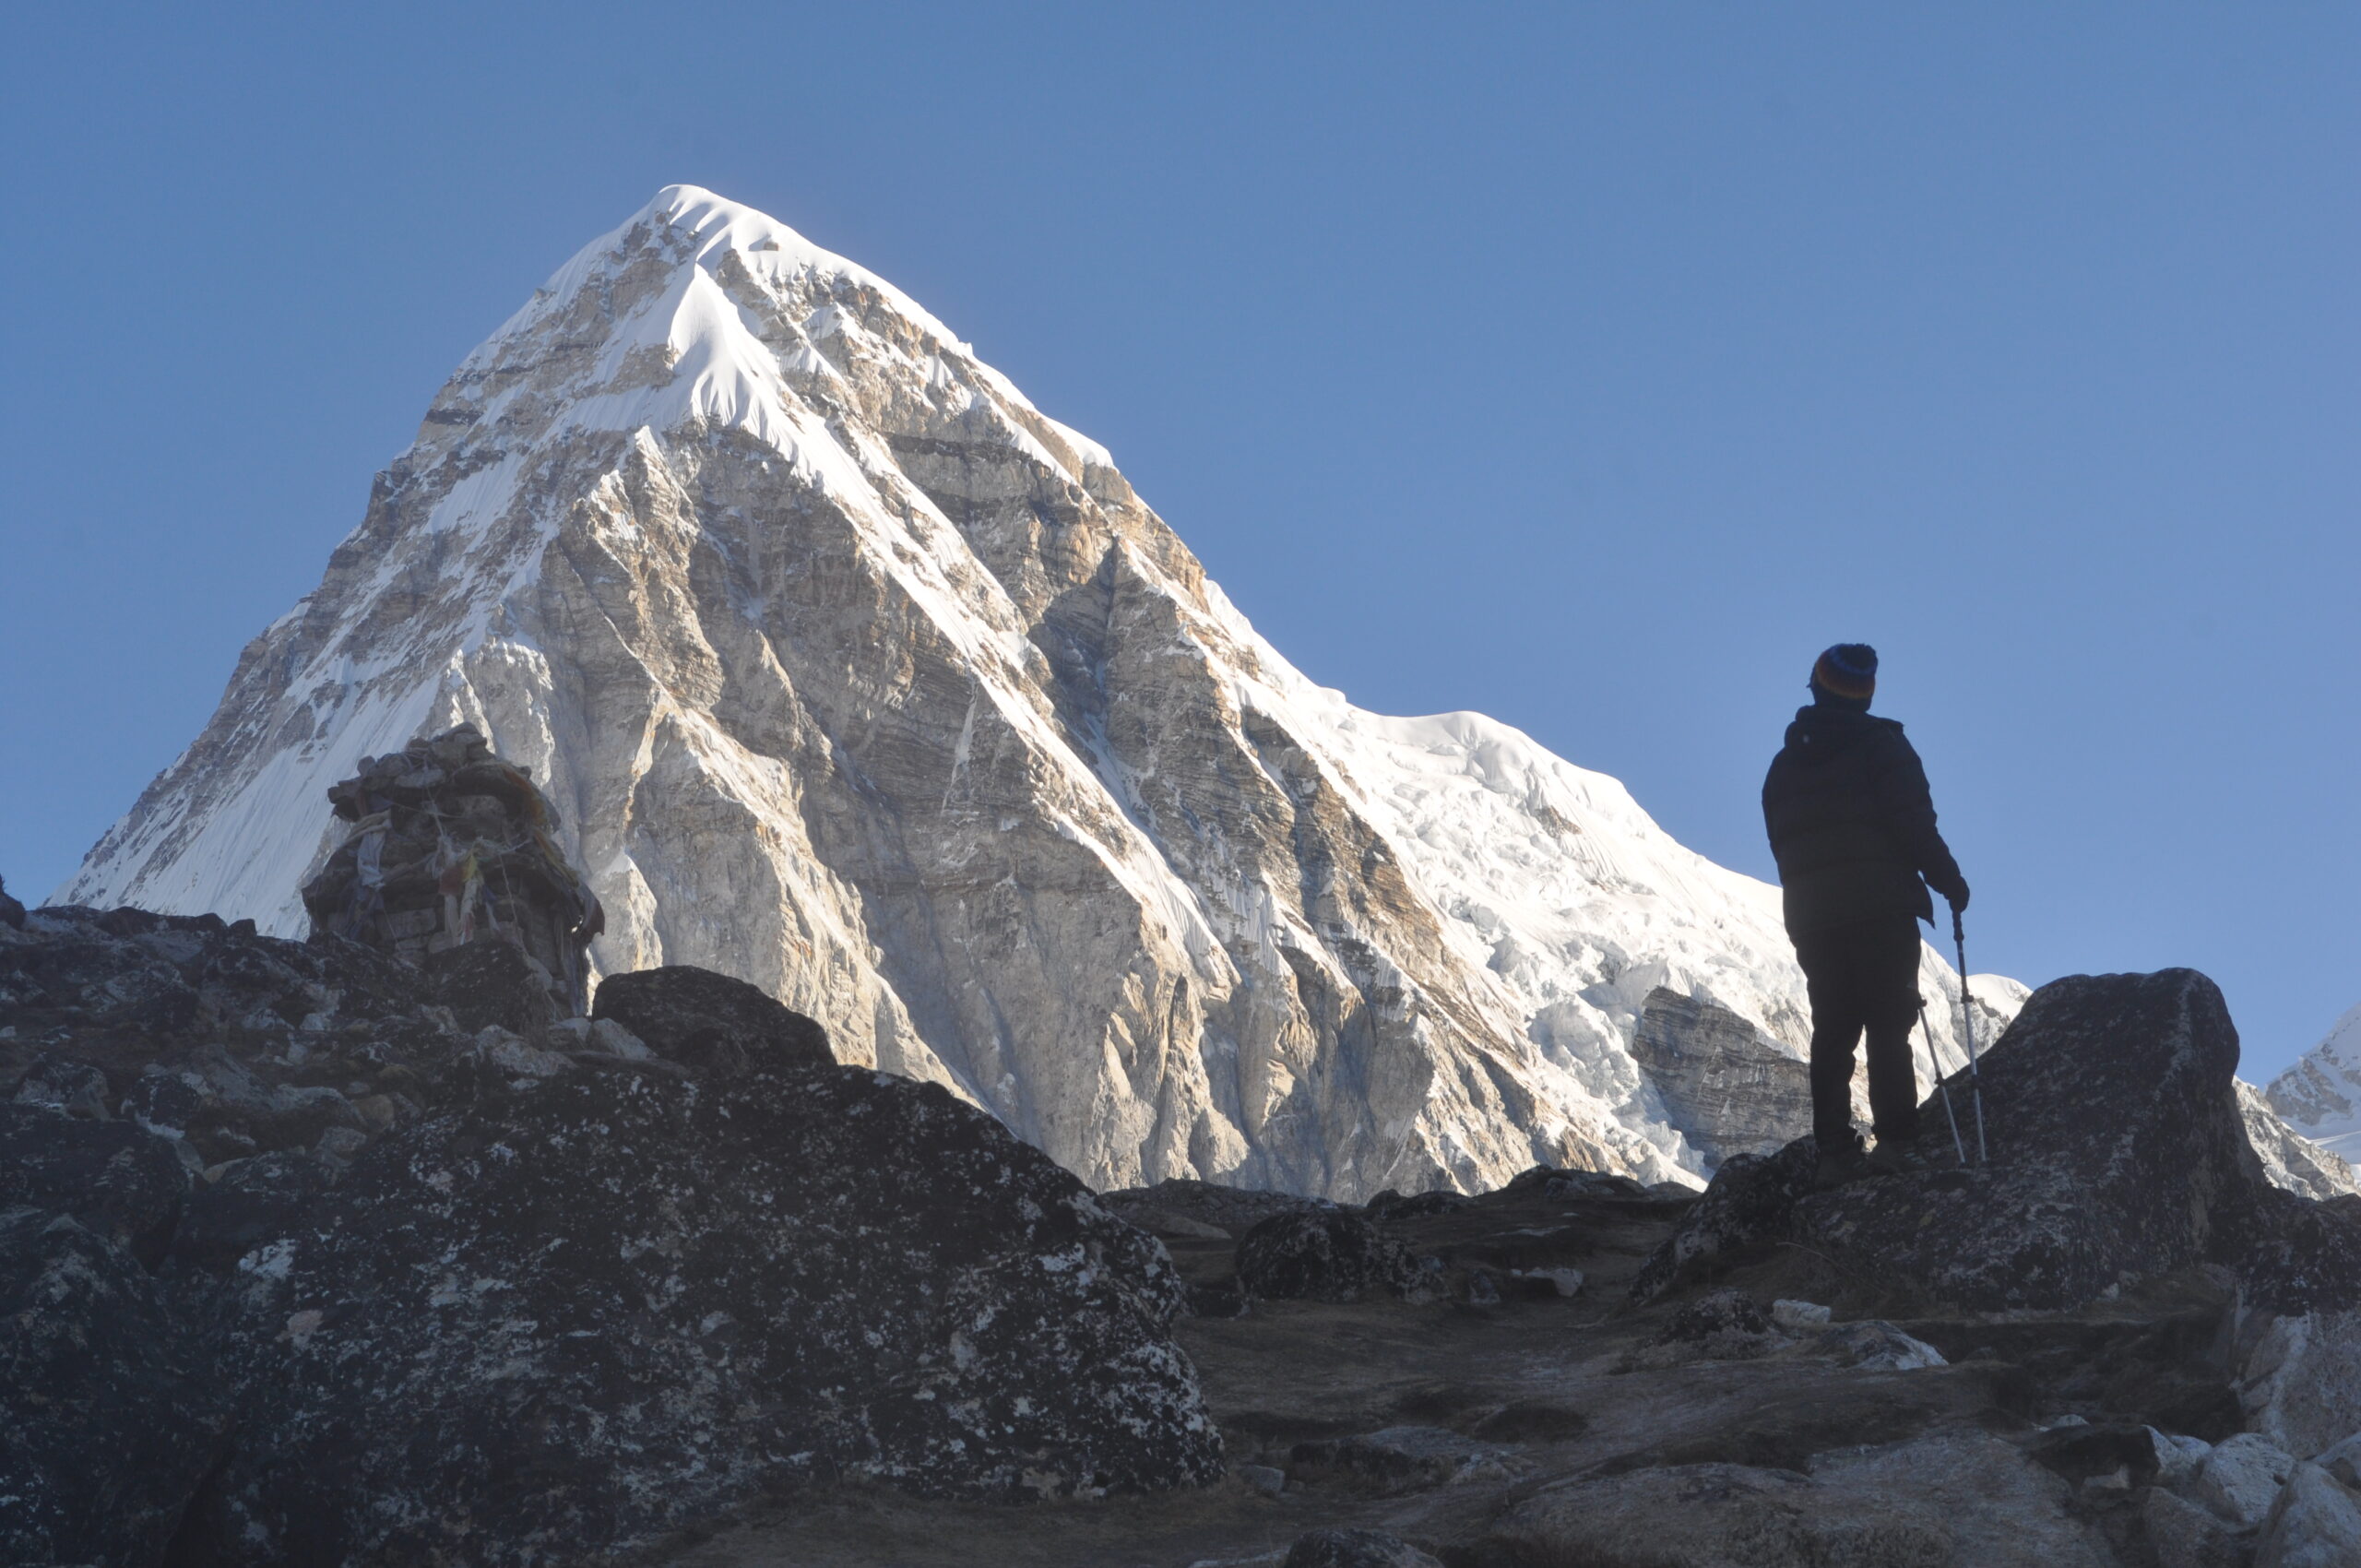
[1636,970,2361,1311]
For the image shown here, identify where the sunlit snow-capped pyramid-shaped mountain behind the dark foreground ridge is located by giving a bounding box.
[59,186,2004,1200]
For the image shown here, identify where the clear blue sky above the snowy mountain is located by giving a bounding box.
[0,0,2361,1076]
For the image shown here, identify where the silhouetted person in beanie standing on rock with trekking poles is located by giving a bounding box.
[1763,642,1966,1181]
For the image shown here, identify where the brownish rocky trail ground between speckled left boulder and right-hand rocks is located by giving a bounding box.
[661,1181,2285,1568]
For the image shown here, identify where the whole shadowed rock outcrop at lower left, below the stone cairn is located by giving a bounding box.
[0,909,1221,1568]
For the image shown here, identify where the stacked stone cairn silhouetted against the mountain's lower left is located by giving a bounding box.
[303,725,607,1017]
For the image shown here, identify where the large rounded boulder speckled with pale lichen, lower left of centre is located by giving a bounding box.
[186,1061,1221,1568]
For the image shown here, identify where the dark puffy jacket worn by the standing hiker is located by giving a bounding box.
[1763,704,1966,931]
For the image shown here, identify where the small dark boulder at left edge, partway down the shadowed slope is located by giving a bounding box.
[0,1105,189,1268]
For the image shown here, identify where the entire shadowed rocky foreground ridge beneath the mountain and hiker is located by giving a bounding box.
[14,887,2361,1568]
